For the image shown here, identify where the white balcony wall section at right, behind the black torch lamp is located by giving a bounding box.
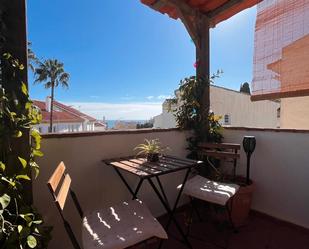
[224,128,309,231]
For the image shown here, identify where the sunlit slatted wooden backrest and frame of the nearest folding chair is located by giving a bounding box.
[47,162,83,249]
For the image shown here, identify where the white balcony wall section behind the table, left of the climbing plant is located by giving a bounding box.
[34,130,190,249]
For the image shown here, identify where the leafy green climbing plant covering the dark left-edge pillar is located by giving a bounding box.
[0,54,51,249]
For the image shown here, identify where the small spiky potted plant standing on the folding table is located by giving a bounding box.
[134,139,164,162]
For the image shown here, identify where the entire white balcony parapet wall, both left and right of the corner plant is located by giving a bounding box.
[34,128,309,249]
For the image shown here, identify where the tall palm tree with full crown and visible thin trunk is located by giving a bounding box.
[34,59,70,132]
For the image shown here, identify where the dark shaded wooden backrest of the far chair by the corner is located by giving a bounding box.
[198,143,240,177]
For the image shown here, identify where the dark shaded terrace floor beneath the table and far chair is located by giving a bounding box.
[134,204,309,249]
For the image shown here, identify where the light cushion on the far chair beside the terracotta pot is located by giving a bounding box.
[183,175,239,206]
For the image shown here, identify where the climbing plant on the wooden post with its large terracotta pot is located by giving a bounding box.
[170,75,254,226]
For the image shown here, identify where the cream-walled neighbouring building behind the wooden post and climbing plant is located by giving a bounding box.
[154,85,280,128]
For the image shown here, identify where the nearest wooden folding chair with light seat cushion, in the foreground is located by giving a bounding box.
[47,162,167,249]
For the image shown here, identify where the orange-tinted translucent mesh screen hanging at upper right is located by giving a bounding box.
[252,0,309,100]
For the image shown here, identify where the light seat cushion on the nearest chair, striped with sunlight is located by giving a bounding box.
[82,200,167,249]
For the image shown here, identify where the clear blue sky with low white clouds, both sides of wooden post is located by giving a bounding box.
[28,0,256,119]
